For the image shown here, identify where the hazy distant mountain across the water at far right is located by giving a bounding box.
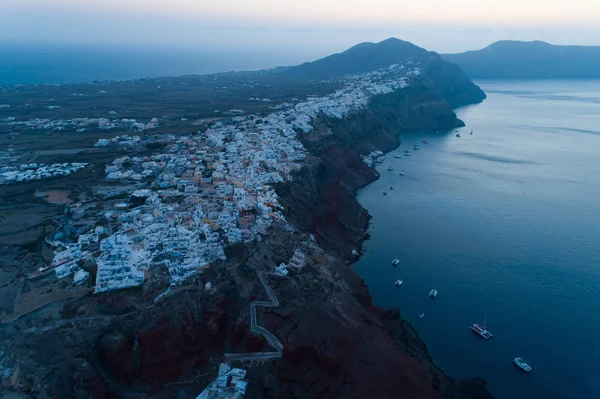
[443,40,600,79]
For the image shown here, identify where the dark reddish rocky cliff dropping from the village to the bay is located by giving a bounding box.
[268,72,492,398]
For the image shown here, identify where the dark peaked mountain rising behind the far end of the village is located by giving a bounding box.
[281,38,485,108]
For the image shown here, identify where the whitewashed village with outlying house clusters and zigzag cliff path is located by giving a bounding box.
[1,63,420,398]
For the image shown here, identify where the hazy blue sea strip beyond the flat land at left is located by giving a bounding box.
[0,43,290,86]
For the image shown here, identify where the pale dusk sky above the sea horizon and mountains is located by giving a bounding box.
[0,0,600,56]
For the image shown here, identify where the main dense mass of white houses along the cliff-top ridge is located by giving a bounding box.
[39,65,419,293]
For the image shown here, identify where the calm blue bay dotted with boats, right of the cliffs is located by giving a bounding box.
[355,81,600,399]
